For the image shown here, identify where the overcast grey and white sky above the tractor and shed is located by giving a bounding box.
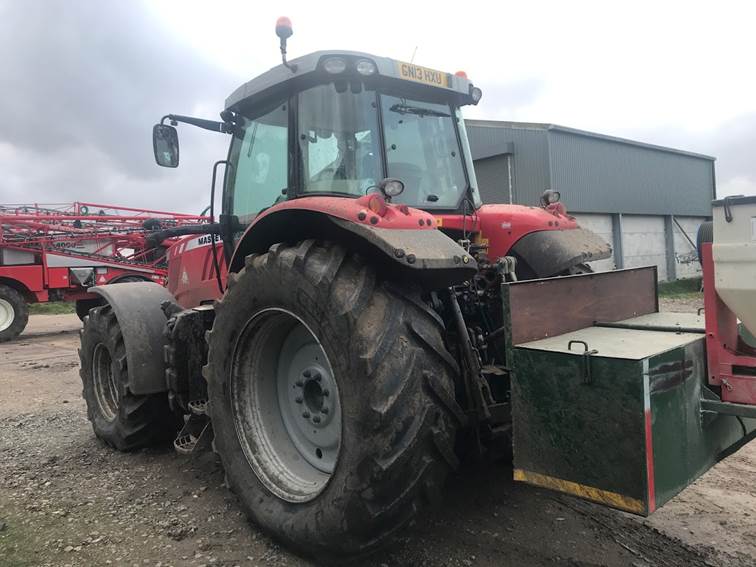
[0,0,756,212]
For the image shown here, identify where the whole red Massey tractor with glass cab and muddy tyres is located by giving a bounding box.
[81,19,610,558]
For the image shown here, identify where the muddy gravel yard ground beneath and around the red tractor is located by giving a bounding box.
[0,308,756,567]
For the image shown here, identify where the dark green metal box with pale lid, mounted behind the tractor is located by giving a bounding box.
[511,312,756,515]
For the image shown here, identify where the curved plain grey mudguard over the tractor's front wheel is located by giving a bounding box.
[90,282,174,396]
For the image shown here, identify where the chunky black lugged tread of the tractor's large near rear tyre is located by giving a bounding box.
[203,240,464,556]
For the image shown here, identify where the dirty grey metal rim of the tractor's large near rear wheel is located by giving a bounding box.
[230,308,341,502]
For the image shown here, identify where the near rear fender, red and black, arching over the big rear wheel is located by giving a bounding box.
[229,196,477,289]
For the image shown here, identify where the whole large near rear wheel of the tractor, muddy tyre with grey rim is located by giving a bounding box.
[205,240,462,561]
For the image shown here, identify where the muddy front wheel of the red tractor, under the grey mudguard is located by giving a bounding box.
[79,305,180,451]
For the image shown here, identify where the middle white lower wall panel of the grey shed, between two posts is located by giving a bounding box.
[622,215,667,281]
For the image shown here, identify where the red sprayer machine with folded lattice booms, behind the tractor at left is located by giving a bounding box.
[0,202,207,342]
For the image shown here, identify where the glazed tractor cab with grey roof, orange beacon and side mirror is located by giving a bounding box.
[155,16,482,224]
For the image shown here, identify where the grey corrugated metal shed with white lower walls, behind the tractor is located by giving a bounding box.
[467,120,716,280]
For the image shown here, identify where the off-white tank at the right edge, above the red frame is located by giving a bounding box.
[713,196,756,334]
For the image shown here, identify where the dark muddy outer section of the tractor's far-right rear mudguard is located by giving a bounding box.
[511,228,612,278]
